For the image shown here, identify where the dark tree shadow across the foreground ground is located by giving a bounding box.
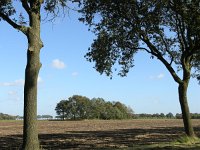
[0,127,200,150]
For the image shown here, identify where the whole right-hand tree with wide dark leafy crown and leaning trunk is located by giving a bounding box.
[80,0,200,137]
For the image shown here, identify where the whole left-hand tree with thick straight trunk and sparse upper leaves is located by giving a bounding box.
[0,0,79,150]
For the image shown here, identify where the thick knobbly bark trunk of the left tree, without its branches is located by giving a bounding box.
[22,13,43,150]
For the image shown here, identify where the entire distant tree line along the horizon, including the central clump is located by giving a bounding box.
[0,111,200,120]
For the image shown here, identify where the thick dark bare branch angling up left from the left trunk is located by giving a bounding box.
[0,12,28,34]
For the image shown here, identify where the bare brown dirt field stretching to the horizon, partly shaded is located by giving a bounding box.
[0,119,200,150]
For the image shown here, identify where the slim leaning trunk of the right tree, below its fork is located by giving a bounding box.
[178,82,195,137]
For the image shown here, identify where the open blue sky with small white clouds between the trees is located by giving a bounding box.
[0,3,200,116]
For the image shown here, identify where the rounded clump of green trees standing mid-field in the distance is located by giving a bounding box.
[55,95,133,120]
